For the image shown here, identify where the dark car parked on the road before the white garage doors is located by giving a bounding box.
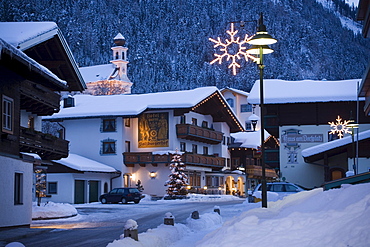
[99,188,143,204]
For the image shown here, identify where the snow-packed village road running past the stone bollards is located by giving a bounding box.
[19,200,243,247]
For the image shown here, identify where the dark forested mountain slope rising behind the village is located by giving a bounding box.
[0,0,370,93]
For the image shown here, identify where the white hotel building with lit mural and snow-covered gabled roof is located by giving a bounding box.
[43,87,245,202]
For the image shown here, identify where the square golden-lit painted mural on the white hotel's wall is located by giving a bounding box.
[138,112,168,148]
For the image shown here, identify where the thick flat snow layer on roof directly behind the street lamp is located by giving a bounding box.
[248,79,362,104]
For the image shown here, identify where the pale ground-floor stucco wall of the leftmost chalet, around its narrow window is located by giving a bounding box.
[0,156,34,227]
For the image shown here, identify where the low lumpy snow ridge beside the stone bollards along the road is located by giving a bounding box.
[107,213,222,247]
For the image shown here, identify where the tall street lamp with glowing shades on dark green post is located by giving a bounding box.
[247,13,277,208]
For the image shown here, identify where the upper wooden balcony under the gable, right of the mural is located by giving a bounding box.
[176,124,224,144]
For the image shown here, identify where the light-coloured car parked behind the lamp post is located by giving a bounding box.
[249,182,306,202]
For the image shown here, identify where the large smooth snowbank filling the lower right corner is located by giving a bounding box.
[197,184,370,247]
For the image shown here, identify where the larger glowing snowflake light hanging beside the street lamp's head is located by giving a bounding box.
[209,23,257,75]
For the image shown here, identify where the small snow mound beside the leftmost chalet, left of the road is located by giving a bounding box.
[32,202,77,219]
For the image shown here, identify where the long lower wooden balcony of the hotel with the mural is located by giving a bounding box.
[123,152,225,169]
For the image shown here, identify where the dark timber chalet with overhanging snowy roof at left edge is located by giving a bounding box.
[0,22,84,227]
